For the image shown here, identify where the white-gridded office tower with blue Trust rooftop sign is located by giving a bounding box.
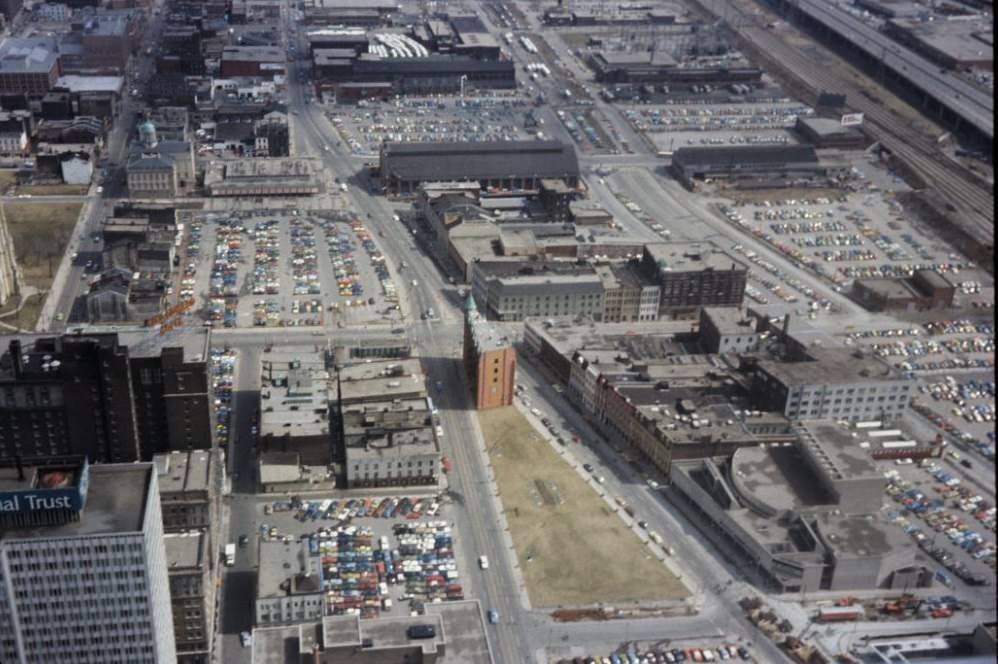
[0,462,177,664]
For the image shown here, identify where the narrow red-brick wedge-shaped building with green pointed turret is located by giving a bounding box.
[464,293,516,410]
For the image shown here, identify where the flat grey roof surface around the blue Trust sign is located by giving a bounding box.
[0,463,153,541]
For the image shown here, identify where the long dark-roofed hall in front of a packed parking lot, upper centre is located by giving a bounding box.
[380,141,579,195]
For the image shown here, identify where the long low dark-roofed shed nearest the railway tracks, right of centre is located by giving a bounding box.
[671,145,848,189]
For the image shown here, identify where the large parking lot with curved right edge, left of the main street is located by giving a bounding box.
[178,210,401,328]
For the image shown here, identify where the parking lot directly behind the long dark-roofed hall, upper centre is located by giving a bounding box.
[326,92,544,155]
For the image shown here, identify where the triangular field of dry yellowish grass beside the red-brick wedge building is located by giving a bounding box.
[478,407,688,607]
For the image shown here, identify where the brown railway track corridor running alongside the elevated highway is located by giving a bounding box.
[694,0,994,247]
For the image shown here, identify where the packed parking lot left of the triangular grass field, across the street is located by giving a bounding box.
[254,496,464,617]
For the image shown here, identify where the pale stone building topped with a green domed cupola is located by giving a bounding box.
[125,117,196,198]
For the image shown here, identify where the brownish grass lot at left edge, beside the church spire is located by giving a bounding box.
[3,203,82,290]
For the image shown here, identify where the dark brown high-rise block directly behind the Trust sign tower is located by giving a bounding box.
[0,328,212,465]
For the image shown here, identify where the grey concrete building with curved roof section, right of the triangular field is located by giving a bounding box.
[667,421,932,593]
